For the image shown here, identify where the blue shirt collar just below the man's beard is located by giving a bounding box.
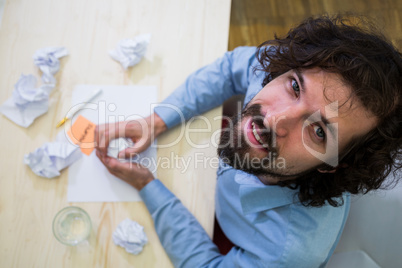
[235,170,299,214]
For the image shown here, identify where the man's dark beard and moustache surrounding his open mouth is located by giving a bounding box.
[218,104,312,180]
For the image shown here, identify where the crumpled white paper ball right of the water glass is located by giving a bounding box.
[113,219,148,255]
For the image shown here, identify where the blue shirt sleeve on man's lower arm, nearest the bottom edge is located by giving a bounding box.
[140,180,265,267]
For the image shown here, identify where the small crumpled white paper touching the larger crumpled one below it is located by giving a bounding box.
[33,47,68,84]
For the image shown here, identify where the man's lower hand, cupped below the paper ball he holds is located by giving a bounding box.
[96,153,154,191]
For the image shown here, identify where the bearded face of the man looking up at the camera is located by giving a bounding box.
[218,68,376,183]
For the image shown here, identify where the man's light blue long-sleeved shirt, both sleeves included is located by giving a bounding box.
[140,47,350,268]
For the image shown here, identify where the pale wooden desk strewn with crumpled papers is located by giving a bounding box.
[0,0,230,268]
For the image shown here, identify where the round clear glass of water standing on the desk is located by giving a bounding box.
[53,206,91,246]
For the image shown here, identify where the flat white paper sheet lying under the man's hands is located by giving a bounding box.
[66,85,157,202]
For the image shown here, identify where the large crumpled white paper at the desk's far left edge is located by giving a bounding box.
[1,74,54,127]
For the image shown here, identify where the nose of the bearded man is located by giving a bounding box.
[264,106,304,137]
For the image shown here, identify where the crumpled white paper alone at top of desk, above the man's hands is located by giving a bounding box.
[109,34,151,69]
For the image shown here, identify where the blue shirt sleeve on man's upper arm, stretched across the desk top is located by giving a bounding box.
[155,47,256,128]
